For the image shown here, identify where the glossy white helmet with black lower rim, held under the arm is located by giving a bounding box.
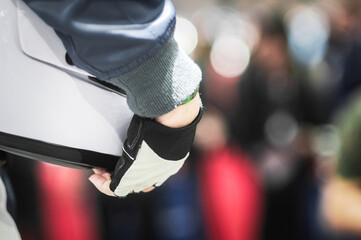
[0,0,133,169]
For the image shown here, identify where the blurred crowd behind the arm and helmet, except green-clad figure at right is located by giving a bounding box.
[3,0,361,240]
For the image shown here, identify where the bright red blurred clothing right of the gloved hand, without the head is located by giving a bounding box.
[200,147,263,240]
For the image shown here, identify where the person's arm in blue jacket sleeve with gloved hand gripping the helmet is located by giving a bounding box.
[0,0,201,239]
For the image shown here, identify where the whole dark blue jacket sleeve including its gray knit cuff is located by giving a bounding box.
[24,0,202,117]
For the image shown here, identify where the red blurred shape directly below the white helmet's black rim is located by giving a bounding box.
[37,163,99,240]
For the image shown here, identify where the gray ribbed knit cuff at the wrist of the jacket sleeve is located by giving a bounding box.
[107,37,202,118]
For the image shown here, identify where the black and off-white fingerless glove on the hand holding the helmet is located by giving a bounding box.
[110,110,202,197]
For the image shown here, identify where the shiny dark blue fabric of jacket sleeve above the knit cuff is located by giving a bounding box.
[24,0,175,79]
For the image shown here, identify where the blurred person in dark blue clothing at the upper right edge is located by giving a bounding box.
[324,0,361,114]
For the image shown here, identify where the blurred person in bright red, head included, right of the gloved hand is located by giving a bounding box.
[195,109,263,240]
